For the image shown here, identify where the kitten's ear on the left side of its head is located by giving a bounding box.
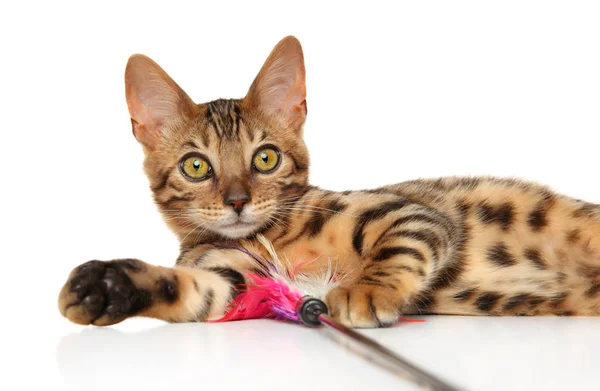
[125,54,197,149]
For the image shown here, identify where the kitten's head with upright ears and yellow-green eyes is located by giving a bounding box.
[125,36,309,242]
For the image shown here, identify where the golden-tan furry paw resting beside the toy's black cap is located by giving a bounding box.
[325,284,406,328]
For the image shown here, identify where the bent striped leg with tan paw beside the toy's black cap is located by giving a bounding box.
[326,205,453,328]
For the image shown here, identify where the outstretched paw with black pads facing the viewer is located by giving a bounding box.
[58,259,151,326]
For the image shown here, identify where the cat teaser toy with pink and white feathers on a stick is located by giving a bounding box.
[213,235,458,391]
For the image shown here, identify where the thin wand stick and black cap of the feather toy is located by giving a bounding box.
[297,297,458,391]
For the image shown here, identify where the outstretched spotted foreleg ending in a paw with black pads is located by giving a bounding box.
[58,247,252,326]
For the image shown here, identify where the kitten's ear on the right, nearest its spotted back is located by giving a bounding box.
[246,36,306,130]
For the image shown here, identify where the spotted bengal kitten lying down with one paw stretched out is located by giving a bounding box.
[59,37,600,327]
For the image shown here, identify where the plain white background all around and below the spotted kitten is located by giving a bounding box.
[0,0,600,390]
